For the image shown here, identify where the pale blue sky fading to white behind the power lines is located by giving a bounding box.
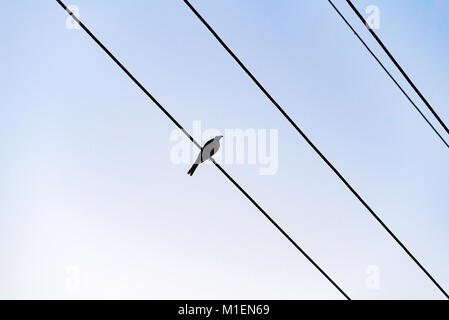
[0,0,449,299]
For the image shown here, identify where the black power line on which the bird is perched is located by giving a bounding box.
[56,0,351,300]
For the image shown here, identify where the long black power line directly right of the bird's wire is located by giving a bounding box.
[184,0,449,299]
